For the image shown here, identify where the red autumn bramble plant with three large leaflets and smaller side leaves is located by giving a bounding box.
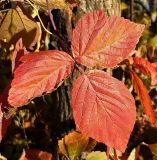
[1,1,157,159]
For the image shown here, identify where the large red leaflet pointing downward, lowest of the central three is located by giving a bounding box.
[72,70,136,151]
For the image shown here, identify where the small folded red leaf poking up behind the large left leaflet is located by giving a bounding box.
[12,38,29,73]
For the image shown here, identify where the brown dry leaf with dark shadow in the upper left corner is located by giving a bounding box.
[0,6,39,47]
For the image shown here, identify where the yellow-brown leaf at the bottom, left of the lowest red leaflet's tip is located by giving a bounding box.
[58,131,95,160]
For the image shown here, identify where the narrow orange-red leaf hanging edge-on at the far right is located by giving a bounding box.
[130,71,155,123]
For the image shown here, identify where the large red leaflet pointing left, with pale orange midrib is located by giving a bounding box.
[8,50,74,107]
